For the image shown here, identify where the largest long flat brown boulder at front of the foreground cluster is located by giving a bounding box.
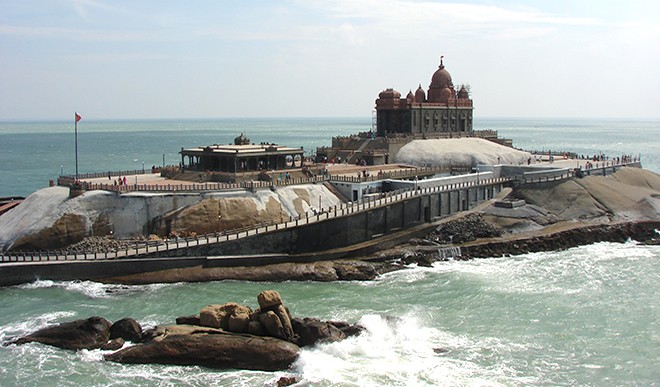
[105,325,300,371]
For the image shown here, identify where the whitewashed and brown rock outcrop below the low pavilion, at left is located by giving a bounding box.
[0,184,341,251]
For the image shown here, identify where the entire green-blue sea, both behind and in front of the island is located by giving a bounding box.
[0,116,660,386]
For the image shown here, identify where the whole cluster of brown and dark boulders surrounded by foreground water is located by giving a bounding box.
[4,290,364,371]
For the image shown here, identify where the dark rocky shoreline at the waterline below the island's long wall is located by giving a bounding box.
[103,218,660,284]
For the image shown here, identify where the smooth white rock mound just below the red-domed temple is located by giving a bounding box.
[394,138,532,167]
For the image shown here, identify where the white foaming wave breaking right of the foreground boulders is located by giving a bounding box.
[294,315,531,386]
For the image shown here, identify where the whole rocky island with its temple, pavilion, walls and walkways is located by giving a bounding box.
[0,60,660,285]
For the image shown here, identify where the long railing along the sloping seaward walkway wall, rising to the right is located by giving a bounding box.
[0,177,512,263]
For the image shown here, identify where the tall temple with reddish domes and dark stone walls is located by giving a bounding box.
[376,58,473,138]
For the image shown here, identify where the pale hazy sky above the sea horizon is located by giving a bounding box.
[0,0,660,120]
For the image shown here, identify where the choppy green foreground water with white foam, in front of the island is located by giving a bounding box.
[0,243,660,386]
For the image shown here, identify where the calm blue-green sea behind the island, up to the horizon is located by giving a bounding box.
[0,118,660,196]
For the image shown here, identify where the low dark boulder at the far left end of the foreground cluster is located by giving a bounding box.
[12,316,112,350]
